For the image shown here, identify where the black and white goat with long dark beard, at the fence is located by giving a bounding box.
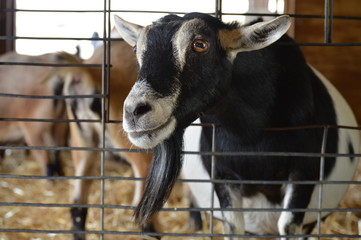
[116,13,359,238]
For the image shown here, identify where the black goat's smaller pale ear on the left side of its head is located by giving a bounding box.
[114,15,143,47]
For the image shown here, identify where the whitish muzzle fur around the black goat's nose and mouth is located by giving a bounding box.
[123,80,179,148]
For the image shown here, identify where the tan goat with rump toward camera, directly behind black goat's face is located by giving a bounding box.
[54,41,160,239]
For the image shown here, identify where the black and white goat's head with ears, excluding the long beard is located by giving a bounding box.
[115,13,290,148]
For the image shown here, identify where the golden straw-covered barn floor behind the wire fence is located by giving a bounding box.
[0,152,361,240]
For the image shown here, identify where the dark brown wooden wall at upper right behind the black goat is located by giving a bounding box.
[291,0,361,125]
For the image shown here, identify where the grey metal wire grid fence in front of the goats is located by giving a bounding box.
[0,0,361,239]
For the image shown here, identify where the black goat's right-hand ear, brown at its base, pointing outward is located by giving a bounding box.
[219,15,291,58]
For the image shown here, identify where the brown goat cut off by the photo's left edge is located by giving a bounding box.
[0,52,68,175]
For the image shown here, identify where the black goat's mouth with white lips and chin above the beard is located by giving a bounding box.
[128,117,176,148]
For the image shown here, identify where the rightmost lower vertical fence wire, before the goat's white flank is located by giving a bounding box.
[317,126,329,239]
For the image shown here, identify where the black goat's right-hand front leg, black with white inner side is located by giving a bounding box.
[277,184,314,240]
